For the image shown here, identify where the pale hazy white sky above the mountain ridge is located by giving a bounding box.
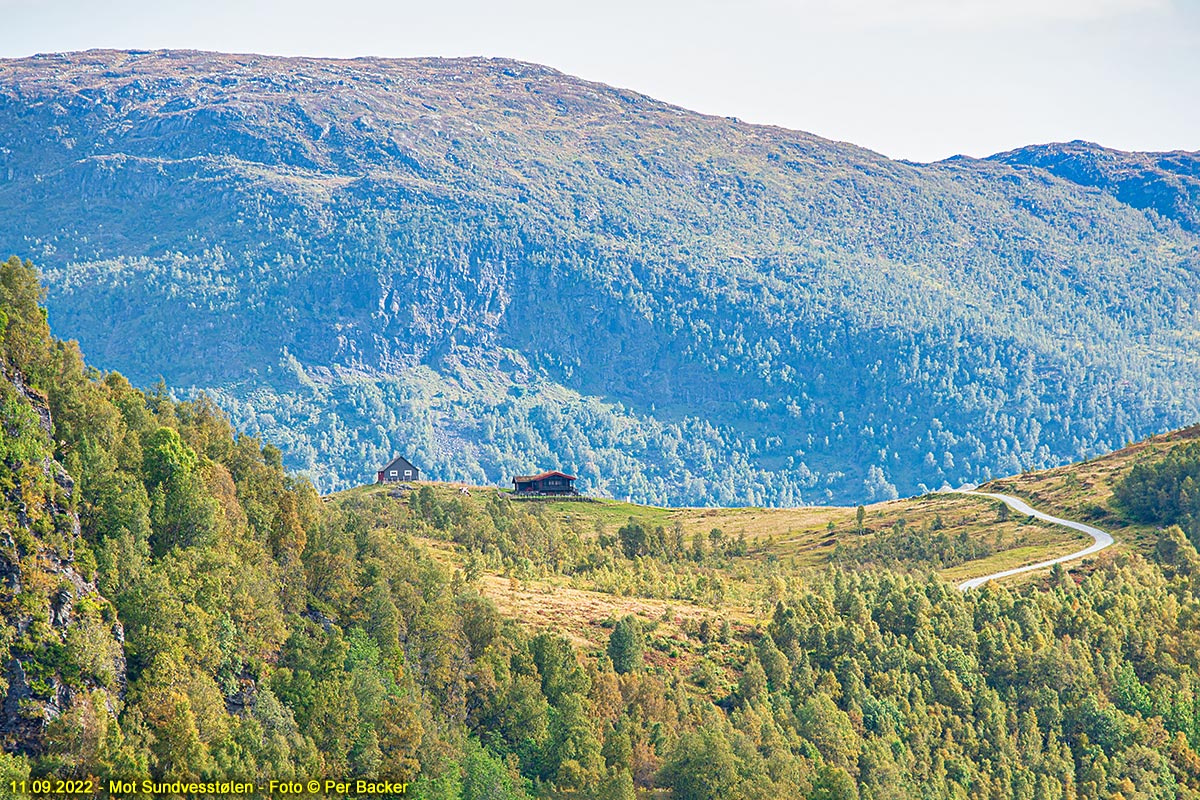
[0,0,1200,161]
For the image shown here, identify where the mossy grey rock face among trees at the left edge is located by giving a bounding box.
[0,367,125,754]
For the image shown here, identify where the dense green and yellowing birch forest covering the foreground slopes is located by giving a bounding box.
[7,251,1200,800]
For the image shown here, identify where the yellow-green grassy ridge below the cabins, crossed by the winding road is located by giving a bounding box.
[326,432,1161,669]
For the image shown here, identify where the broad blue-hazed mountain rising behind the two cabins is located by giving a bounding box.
[0,50,1200,505]
